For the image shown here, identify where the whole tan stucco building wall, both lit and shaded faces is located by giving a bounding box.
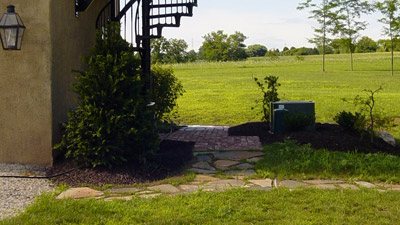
[0,0,106,166]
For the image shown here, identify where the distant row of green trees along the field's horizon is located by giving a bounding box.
[151,31,400,64]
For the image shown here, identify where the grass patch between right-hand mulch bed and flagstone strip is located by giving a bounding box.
[256,141,400,183]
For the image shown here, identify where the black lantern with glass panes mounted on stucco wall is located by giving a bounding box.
[0,5,25,50]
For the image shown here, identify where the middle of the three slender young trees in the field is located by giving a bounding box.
[333,0,373,71]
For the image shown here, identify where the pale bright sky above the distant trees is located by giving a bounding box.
[163,0,385,51]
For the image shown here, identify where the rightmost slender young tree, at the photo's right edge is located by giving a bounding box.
[376,0,400,76]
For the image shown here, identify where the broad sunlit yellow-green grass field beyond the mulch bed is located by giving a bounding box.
[173,53,400,137]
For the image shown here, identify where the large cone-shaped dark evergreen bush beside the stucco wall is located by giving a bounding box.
[56,24,158,167]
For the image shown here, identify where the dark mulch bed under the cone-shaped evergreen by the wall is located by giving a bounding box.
[48,140,194,186]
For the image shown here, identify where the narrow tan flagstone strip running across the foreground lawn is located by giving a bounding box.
[57,175,400,201]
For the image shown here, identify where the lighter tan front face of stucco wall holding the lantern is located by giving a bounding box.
[0,0,52,165]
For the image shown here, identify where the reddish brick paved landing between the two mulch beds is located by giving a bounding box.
[160,125,262,151]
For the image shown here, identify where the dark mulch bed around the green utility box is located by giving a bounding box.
[228,122,400,155]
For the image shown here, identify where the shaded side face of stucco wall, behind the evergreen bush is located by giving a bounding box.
[50,0,108,160]
